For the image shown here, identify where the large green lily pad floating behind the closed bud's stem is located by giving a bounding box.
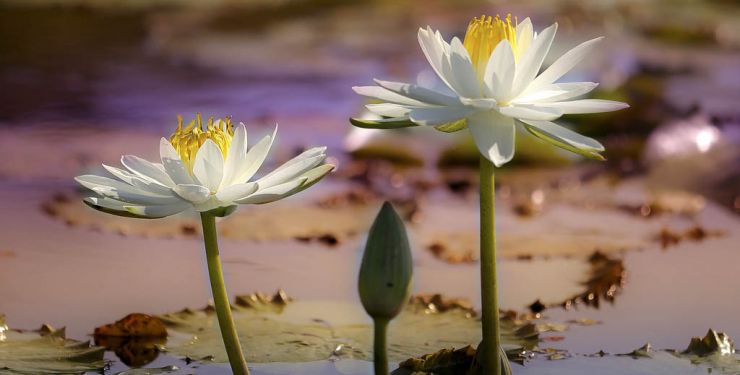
[160,297,563,363]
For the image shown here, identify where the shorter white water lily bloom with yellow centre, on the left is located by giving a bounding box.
[75,115,334,218]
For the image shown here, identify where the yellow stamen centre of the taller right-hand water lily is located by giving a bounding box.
[463,14,517,79]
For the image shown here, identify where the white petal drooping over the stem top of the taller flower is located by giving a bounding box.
[468,111,516,167]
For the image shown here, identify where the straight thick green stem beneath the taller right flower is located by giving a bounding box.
[479,156,501,375]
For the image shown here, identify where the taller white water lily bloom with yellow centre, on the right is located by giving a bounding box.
[353,16,628,166]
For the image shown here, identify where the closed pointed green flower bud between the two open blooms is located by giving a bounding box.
[358,202,413,319]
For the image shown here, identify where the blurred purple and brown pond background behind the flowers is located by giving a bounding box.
[0,0,740,374]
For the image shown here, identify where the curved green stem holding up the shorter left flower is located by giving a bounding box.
[200,212,249,375]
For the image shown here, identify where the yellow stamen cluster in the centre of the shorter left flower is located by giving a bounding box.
[170,113,234,172]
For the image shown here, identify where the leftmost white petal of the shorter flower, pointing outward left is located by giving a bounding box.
[75,175,181,205]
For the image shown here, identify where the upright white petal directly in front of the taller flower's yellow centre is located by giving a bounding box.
[483,40,516,101]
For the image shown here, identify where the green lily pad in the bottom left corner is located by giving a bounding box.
[0,315,105,375]
